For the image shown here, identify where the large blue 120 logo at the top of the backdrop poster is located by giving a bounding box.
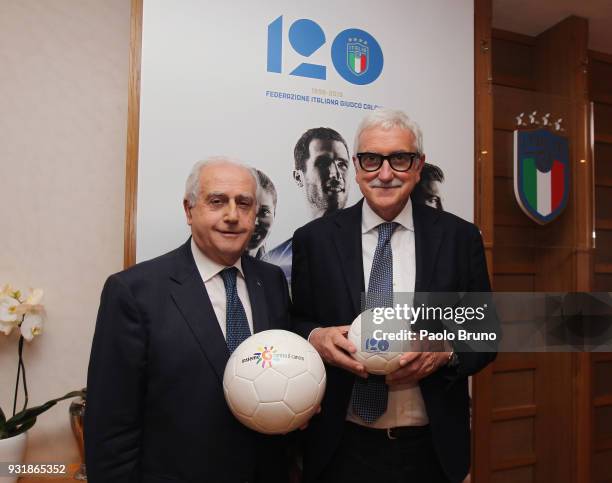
[267,15,384,85]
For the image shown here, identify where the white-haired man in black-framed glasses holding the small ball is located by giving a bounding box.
[292,110,495,483]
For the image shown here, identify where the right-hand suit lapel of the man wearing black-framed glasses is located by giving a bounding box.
[412,203,443,292]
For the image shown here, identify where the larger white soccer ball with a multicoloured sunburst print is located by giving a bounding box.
[223,330,326,434]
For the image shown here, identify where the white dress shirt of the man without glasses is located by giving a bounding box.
[191,238,253,339]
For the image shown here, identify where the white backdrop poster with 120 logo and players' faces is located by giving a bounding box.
[136,0,474,280]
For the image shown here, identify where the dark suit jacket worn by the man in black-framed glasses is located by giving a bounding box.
[291,200,495,481]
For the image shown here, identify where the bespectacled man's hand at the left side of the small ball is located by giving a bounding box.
[309,325,368,378]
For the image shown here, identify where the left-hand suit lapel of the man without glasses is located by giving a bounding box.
[171,240,229,380]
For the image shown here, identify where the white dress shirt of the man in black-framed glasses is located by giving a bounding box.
[347,198,429,428]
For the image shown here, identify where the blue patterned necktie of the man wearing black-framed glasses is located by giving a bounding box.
[351,222,397,423]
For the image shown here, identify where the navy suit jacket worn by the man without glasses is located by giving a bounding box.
[85,240,289,483]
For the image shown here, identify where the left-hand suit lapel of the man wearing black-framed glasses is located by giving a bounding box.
[333,199,365,314]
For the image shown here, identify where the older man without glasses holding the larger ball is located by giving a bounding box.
[85,159,289,483]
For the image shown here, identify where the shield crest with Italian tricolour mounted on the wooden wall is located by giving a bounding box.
[514,128,570,225]
